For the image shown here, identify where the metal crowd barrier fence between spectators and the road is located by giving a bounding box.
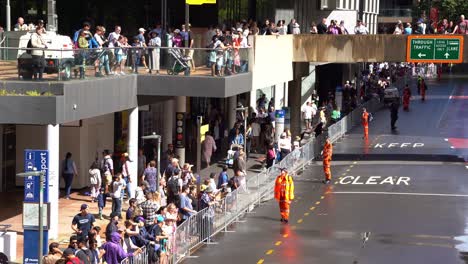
[121,99,382,264]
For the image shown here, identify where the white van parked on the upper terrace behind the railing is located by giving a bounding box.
[17,32,75,79]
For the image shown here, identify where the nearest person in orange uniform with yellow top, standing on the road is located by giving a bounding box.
[275,168,294,223]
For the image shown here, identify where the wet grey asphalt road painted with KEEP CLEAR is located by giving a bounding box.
[185,77,468,264]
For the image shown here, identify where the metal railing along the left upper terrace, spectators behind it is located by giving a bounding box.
[0,43,253,80]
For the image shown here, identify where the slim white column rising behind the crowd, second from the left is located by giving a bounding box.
[127,107,138,198]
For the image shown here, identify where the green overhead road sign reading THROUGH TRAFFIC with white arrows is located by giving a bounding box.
[407,36,463,63]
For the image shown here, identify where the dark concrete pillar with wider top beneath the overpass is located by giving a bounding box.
[288,62,309,137]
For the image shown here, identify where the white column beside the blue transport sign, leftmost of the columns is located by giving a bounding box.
[47,125,60,239]
